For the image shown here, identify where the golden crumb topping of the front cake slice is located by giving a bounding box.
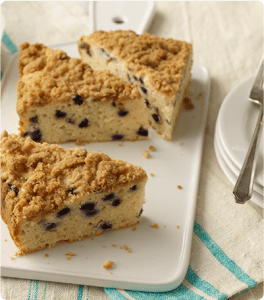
[1,131,147,227]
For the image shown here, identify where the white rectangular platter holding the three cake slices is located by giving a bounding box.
[0,43,210,292]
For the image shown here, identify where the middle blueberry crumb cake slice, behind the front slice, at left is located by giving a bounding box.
[17,42,149,143]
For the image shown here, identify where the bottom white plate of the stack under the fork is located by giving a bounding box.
[214,129,264,208]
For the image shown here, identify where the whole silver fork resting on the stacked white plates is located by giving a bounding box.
[233,55,264,204]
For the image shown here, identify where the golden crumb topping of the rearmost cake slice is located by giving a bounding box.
[78,30,192,96]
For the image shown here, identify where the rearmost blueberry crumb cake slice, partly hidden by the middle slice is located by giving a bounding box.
[78,30,192,140]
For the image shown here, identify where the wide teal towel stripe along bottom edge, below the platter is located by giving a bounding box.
[122,283,206,300]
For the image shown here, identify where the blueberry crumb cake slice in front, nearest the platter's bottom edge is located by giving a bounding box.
[1,131,147,253]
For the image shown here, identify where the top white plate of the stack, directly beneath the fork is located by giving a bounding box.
[217,76,264,186]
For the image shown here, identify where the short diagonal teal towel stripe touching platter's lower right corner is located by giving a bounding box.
[185,266,227,300]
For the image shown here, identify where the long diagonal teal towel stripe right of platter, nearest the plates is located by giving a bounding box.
[193,221,257,287]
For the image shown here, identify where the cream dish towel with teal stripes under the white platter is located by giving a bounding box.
[1,1,264,300]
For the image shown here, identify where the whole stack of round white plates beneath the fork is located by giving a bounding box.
[214,76,264,208]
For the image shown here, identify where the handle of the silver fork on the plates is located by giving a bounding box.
[233,105,264,204]
